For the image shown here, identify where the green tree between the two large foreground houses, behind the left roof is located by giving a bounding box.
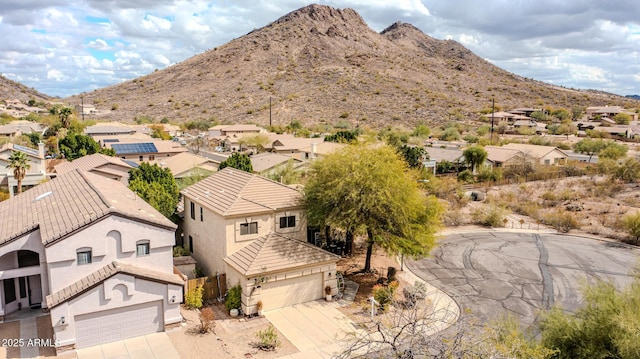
[129,162,180,218]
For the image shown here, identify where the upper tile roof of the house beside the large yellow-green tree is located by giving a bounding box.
[182,167,302,217]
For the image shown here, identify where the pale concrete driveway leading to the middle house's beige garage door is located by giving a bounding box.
[264,300,356,359]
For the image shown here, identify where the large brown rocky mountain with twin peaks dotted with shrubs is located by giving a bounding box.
[68,5,629,127]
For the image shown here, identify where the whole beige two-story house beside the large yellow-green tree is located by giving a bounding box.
[182,168,339,313]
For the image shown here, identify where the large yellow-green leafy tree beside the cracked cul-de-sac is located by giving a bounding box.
[304,145,441,271]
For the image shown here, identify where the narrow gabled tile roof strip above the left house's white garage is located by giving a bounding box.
[46,261,184,308]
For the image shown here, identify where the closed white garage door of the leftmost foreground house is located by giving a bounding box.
[75,301,164,348]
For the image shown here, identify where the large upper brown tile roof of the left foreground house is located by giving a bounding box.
[0,170,176,245]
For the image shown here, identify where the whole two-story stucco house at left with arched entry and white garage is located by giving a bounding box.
[0,170,184,352]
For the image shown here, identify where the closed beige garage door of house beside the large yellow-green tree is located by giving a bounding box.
[260,273,323,311]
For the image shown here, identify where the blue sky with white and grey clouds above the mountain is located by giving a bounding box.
[0,0,640,97]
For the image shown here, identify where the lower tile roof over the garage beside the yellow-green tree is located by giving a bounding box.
[224,233,340,278]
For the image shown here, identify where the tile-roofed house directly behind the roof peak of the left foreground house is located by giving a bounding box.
[55,153,133,185]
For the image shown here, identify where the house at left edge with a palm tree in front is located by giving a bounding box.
[0,143,48,197]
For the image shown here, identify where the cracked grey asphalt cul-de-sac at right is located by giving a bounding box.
[407,232,640,325]
